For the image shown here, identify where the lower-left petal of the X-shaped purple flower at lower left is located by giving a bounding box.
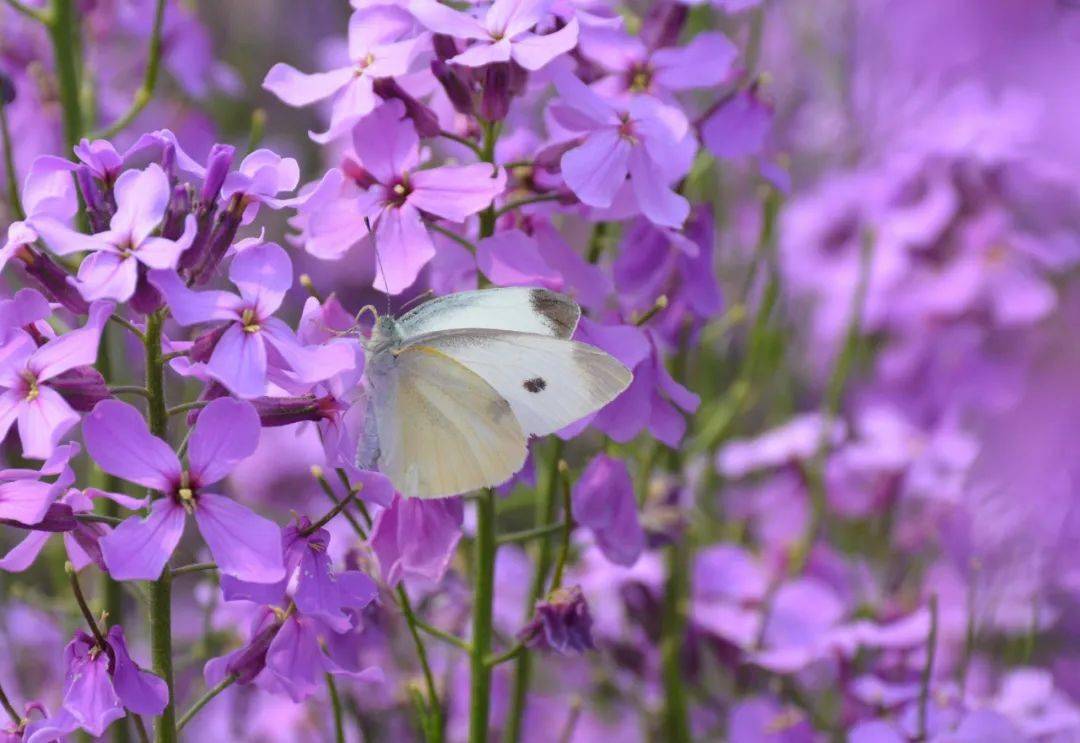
[98,497,186,580]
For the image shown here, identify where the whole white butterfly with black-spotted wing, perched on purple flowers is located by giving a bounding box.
[356,287,633,498]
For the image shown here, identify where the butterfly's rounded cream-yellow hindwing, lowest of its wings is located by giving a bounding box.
[370,343,527,498]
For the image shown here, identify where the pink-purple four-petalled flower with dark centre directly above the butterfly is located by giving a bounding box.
[301,100,507,294]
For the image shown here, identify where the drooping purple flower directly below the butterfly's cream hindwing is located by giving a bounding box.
[369,496,464,586]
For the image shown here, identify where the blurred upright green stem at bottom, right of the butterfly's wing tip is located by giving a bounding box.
[660,539,691,743]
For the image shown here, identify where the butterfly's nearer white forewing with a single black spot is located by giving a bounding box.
[406,328,633,436]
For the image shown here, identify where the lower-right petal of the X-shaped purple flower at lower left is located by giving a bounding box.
[195,492,285,583]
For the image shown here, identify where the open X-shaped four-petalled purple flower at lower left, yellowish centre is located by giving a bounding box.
[83,397,285,583]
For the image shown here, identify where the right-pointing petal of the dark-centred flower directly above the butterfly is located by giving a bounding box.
[408,163,507,221]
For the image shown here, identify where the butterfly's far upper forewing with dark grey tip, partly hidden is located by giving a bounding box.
[397,286,581,340]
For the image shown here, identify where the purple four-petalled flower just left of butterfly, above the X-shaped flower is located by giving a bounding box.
[149,243,355,397]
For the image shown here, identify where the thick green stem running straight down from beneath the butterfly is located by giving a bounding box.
[469,489,496,743]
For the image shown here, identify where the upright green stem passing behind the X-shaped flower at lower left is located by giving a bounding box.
[145,311,177,743]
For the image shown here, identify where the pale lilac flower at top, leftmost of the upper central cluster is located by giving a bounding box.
[262,5,428,143]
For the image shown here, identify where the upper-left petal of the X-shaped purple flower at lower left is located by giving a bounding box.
[82,400,180,491]
